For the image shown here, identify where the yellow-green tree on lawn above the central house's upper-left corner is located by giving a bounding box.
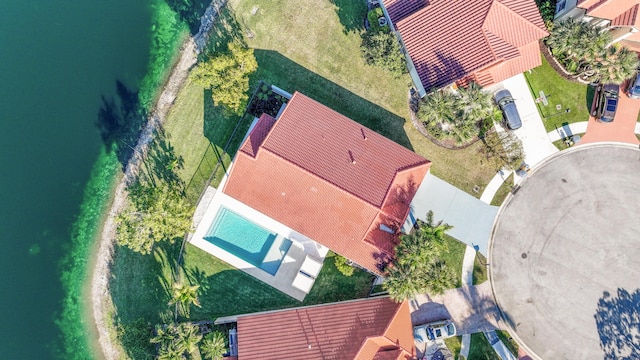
[190,42,258,113]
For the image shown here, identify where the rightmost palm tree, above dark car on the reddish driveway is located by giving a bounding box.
[594,44,640,85]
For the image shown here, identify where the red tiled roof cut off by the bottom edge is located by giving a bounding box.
[238,297,414,360]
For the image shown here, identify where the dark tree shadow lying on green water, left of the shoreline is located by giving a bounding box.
[96,80,147,169]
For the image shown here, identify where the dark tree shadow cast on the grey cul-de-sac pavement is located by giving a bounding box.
[594,289,640,360]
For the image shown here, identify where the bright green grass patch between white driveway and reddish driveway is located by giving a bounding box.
[524,56,593,132]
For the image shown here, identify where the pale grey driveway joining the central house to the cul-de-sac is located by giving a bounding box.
[403,173,498,255]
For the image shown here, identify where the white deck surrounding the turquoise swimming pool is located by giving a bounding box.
[189,174,329,301]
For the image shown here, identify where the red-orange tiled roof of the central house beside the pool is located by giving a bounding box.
[223,93,431,273]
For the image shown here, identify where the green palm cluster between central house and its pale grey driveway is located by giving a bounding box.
[382,211,457,302]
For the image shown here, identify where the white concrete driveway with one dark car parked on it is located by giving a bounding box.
[487,74,558,167]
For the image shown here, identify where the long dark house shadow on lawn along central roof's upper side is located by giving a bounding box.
[251,49,413,150]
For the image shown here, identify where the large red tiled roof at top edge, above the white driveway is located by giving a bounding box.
[384,0,548,90]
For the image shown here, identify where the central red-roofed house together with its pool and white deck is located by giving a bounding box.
[191,92,431,298]
